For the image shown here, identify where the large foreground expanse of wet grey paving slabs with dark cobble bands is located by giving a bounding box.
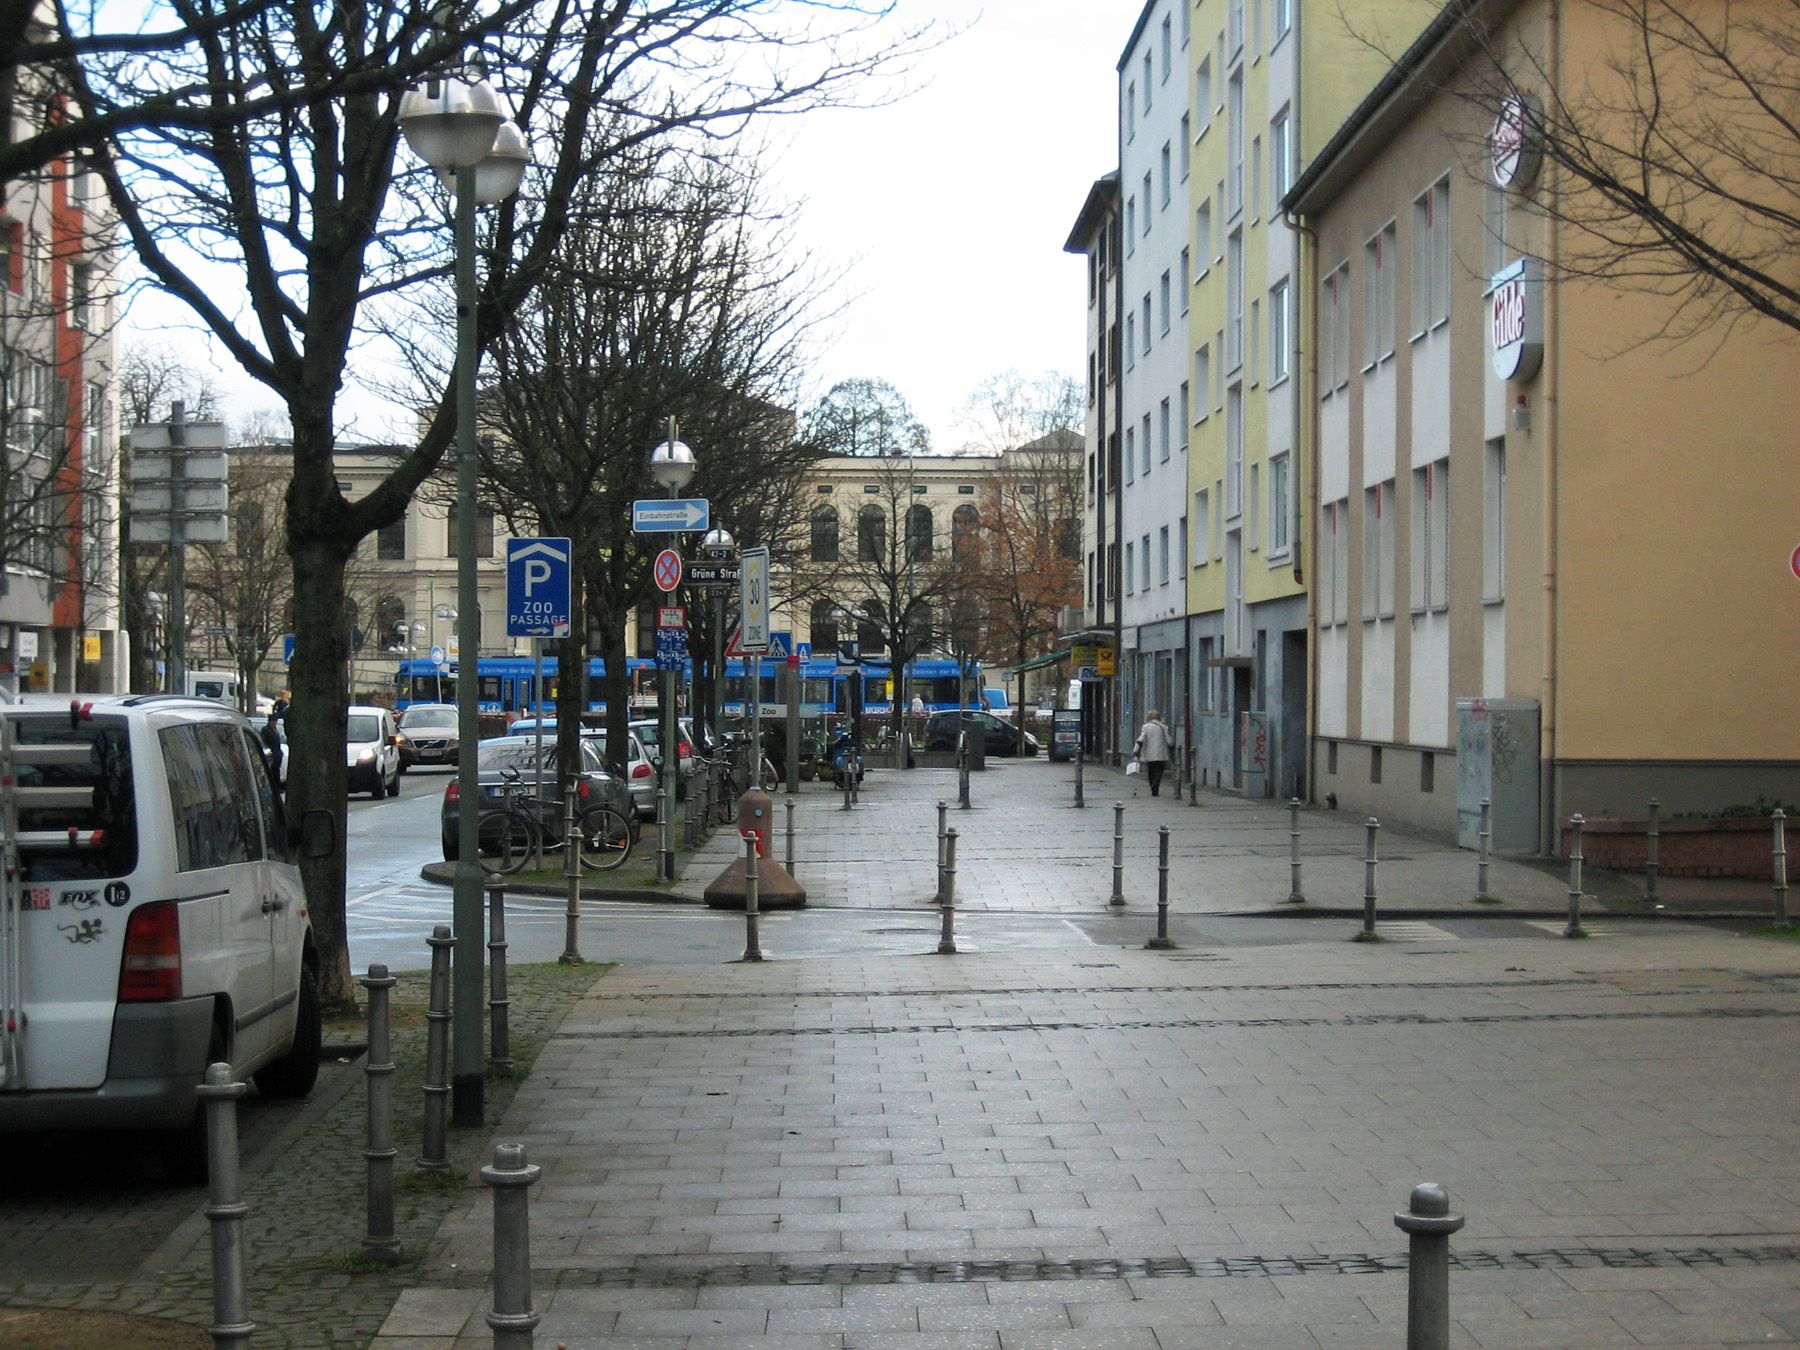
[374,835,1800,1350]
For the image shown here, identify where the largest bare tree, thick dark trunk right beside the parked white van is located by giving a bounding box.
[56,0,916,1003]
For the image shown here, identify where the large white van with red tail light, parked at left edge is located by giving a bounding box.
[0,695,338,1181]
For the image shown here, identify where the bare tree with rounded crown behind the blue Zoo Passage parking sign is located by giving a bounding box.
[482,135,814,763]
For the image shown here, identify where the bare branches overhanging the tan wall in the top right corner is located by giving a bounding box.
[1451,0,1800,349]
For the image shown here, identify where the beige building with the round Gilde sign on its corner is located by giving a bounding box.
[1287,0,1800,851]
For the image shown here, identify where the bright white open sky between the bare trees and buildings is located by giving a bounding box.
[126,0,1143,452]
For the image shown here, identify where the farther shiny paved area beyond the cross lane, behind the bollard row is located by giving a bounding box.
[675,760,1591,914]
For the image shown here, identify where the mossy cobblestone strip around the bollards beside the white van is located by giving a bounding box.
[0,965,607,1350]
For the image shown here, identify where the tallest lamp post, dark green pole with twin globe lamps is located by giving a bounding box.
[400,67,531,1125]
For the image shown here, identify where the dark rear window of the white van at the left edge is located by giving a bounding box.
[14,713,137,882]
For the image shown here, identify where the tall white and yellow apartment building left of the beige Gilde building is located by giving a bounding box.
[1066,0,1435,796]
